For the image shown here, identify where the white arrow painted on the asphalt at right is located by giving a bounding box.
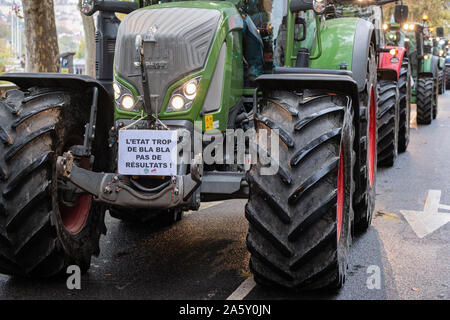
[400,190,450,238]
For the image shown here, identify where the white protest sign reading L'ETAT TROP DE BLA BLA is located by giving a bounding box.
[118,130,177,176]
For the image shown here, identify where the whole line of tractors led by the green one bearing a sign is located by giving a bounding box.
[0,0,448,290]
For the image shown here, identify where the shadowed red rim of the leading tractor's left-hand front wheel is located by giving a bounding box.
[59,138,92,234]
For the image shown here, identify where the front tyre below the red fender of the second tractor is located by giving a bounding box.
[378,80,400,167]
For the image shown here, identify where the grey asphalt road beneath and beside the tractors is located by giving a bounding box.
[0,92,450,300]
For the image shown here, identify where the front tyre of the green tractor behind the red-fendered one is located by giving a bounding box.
[417,77,436,124]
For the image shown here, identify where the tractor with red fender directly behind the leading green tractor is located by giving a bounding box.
[338,2,411,167]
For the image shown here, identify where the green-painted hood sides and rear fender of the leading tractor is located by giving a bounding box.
[110,0,368,131]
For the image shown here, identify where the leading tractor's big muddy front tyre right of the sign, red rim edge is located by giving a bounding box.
[245,91,355,290]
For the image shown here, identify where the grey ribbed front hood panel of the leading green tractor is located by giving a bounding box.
[114,7,221,112]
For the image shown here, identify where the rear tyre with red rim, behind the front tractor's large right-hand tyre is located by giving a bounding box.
[353,45,378,233]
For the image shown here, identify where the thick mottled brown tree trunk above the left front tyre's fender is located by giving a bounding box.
[22,0,59,72]
